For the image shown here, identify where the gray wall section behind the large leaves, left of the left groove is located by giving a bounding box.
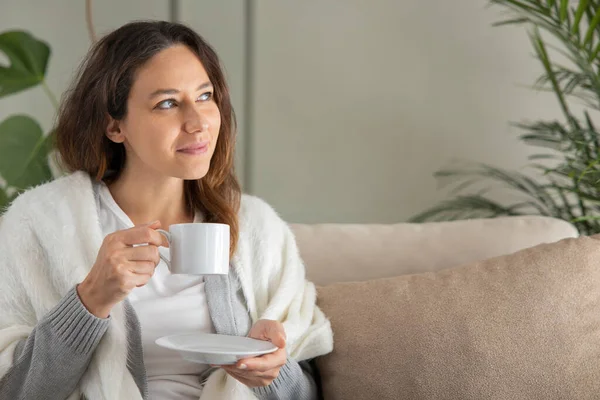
[0,0,169,136]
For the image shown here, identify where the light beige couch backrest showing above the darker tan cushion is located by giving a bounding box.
[292,216,577,285]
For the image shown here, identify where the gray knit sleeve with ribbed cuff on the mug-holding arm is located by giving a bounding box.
[0,288,110,399]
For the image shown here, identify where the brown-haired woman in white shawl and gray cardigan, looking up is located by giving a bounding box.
[0,22,333,400]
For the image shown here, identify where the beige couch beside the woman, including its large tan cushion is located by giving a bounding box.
[291,216,600,400]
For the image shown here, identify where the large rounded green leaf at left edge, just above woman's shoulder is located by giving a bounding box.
[0,115,52,190]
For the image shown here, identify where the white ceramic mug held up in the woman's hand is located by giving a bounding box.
[157,223,230,275]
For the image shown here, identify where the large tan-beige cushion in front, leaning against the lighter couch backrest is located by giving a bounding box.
[317,236,600,400]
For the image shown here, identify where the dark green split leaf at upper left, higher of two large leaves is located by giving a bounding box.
[0,31,50,97]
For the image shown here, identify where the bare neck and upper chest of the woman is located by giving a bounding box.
[108,167,194,229]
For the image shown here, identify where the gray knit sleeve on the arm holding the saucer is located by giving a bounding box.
[252,359,319,400]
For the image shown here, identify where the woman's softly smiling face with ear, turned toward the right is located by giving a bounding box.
[107,45,221,179]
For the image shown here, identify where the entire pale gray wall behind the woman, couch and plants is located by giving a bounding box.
[0,0,556,222]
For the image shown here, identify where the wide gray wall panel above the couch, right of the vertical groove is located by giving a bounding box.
[251,0,555,222]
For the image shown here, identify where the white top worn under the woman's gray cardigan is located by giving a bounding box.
[94,183,216,400]
